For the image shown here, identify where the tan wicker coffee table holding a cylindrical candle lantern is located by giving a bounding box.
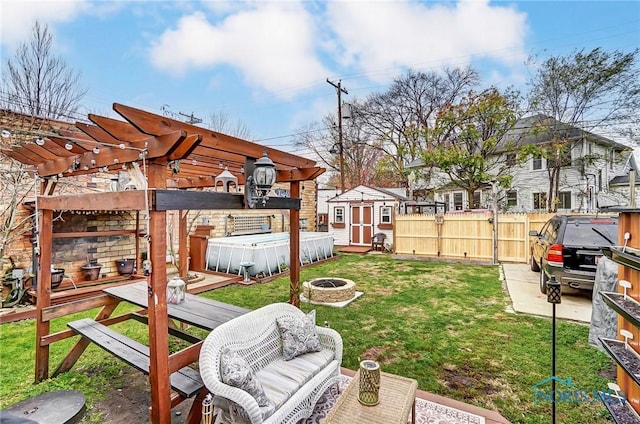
[322,370,418,424]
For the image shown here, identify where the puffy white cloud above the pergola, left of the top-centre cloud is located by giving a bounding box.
[150,2,328,97]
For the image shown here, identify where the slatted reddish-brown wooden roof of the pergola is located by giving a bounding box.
[0,103,324,188]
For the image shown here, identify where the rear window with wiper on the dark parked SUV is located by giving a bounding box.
[563,218,618,247]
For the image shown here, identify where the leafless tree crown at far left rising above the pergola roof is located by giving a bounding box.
[2,21,87,119]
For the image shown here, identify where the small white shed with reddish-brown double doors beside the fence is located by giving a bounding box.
[327,185,408,246]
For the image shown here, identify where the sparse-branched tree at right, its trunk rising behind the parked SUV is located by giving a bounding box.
[529,48,640,212]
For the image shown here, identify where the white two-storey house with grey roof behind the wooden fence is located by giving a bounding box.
[409,115,637,212]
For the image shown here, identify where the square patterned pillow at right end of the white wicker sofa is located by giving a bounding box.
[276,310,322,361]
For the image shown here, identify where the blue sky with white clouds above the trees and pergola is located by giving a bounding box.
[0,0,640,154]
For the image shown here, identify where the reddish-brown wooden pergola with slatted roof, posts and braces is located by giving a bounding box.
[3,104,324,424]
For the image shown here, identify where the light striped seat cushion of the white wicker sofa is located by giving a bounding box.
[256,349,335,409]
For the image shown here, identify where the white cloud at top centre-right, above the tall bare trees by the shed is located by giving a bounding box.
[327,0,527,79]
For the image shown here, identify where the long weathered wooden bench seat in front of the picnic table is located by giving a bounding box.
[67,318,204,398]
